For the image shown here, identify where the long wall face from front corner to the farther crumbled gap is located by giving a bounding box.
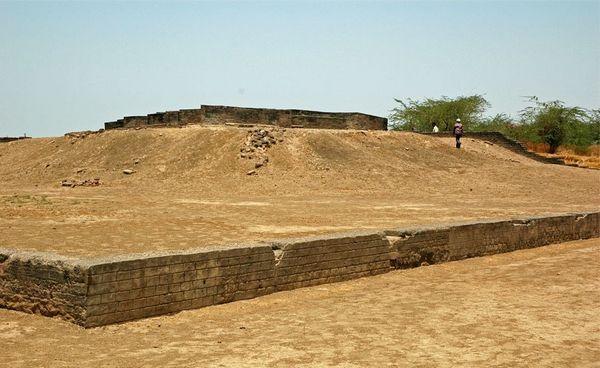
[84,233,390,327]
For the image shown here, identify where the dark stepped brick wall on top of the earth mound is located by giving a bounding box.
[104,105,387,130]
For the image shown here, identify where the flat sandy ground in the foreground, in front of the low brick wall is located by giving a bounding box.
[0,239,600,368]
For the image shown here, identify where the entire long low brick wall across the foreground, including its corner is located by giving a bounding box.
[0,212,600,327]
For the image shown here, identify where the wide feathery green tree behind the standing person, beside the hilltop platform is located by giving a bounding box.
[390,95,490,132]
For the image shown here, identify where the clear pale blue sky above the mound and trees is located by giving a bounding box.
[0,1,600,136]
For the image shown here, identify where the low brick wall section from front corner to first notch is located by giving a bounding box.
[85,246,274,327]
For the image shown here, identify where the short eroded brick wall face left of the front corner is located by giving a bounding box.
[0,249,87,324]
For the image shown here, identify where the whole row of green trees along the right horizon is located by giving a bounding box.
[390,95,600,153]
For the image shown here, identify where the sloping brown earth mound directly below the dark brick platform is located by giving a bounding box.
[0,127,556,191]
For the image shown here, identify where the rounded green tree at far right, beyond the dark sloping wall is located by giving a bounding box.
[520,96,591,153]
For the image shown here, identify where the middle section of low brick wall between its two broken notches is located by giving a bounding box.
[272,233,390,291]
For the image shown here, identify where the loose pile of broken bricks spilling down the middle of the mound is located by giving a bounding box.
[240,127,285,175]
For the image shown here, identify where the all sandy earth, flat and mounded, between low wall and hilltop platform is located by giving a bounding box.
[0,126,600,257]
